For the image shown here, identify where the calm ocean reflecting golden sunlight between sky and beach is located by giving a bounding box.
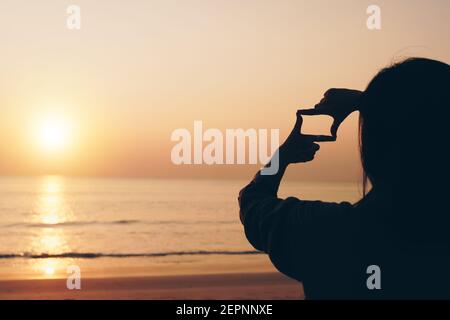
[0,176,361,278]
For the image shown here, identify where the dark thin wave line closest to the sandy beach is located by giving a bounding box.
[0,251,263,259]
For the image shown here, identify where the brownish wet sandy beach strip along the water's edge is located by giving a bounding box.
[0,272,303,300]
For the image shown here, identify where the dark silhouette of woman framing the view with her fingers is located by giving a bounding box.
[239,58,450,299]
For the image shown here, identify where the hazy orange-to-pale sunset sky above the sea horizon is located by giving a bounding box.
[0,0,450,180]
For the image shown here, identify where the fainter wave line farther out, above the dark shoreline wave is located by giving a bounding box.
[0,220,236,228]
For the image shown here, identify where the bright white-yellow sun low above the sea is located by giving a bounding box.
[36,115,71,152]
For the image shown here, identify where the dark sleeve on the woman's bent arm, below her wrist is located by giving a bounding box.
[239,174,351,281]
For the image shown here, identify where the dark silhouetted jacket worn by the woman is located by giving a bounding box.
[239,174,450,299]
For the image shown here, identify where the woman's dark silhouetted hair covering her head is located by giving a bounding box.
[359,58,450,194]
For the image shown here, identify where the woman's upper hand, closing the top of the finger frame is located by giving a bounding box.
[297,89,362,138]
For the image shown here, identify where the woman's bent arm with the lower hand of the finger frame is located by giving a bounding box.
[239,115,332,279]
